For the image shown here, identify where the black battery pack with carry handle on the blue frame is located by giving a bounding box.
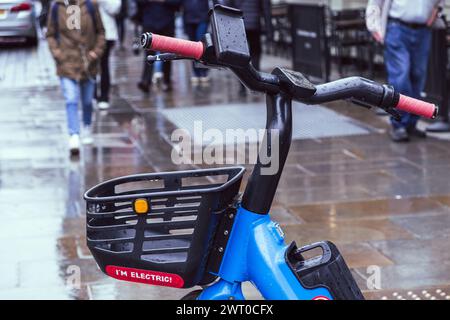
[285,241,364,300]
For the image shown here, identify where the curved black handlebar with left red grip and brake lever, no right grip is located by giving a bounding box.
[142,33,399,116]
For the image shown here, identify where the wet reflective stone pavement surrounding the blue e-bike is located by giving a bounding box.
[0,35,450,299]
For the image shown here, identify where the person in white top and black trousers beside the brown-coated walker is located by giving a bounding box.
[97,0,121,110]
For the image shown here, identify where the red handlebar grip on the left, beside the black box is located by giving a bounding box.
[149,33,205,60]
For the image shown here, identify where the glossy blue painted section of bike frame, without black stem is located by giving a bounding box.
[198,207,332,300]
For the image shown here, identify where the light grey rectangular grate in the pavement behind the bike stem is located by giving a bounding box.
[161,103,375,144]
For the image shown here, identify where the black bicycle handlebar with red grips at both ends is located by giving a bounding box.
[141,32,438,119]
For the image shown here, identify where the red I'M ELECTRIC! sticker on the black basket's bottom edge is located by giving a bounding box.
[106,266,184,288]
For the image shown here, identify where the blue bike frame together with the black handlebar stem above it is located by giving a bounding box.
[199,94,332,300]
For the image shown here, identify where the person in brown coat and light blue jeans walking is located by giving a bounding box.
[47,0,105,155]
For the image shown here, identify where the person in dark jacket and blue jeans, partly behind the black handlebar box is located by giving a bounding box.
[182,0,210,85]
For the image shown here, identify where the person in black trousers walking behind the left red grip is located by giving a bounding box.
[137,0,181,93]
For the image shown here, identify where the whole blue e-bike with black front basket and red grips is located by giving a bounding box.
[85,6,437,300]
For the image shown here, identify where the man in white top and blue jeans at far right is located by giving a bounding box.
[366,0,444,142]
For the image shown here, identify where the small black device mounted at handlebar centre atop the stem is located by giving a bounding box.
[272,68,317,100]
